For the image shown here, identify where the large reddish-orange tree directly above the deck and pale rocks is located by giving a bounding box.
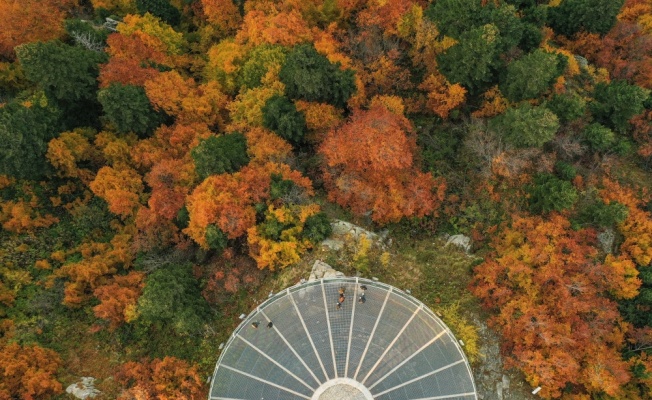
[319,105,446,223]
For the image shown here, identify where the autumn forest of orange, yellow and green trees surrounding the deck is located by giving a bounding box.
[0,0,652,400]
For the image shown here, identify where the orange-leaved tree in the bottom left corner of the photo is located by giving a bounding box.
[0,343,63,400]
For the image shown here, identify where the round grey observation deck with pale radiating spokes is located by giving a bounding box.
[209,278,477,400]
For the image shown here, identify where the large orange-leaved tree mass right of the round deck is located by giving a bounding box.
[471,214,641,398]
